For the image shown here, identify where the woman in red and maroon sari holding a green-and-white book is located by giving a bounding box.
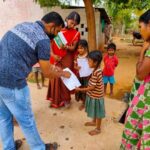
[47,11,80,108]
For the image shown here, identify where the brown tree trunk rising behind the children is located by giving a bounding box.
[83,0,97,51]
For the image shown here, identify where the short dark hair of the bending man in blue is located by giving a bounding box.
[41,11,64,27]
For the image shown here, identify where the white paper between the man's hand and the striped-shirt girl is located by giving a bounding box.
[61,68,81,91]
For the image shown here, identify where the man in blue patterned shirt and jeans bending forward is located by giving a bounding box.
[0,12,68,150]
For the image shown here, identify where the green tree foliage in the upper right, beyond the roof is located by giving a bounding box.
[103,0,150,31]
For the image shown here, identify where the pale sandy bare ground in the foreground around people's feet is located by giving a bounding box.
[0,84,125,150]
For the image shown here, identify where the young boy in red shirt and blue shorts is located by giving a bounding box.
[103,43,118,96]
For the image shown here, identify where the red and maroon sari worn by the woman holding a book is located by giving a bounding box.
[47,28,80,108]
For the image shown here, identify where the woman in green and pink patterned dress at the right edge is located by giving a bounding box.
[120,10,150,150]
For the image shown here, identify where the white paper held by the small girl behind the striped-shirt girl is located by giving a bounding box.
[77,58,93,77]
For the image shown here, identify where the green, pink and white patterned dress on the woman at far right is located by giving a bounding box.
[120,50,150,150]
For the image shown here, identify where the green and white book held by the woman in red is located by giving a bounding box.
[54,32,68,48]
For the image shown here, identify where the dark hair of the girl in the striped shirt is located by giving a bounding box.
[88,50,103,69]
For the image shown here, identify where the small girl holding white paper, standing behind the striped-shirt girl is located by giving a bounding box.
[74,40,89,110]
